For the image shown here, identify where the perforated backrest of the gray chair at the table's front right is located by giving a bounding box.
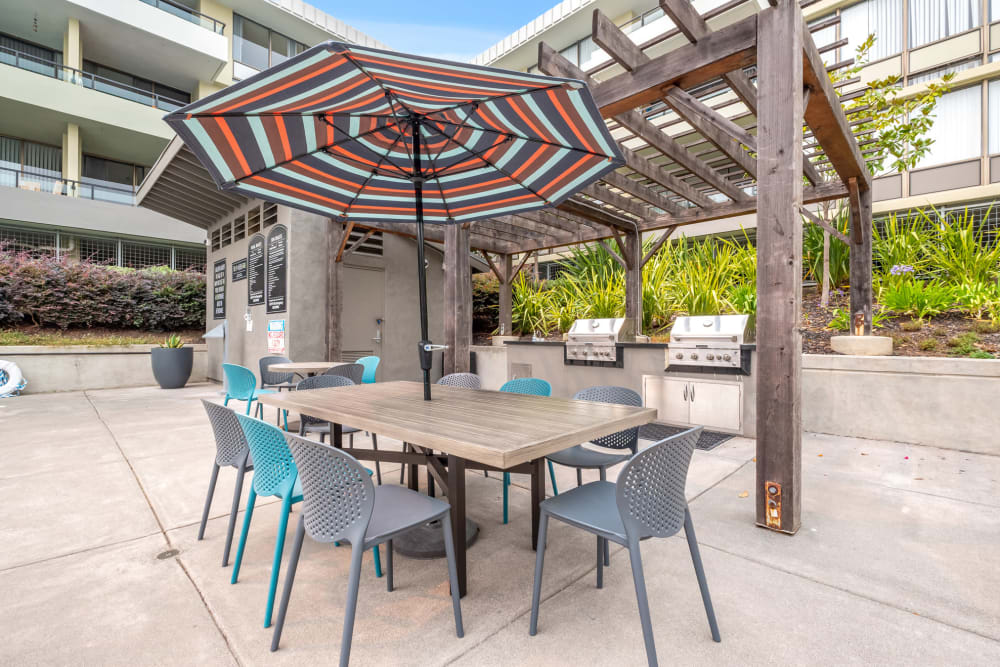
[615,426,702,540]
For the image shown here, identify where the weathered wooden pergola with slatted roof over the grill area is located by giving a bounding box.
[331,0,872,533]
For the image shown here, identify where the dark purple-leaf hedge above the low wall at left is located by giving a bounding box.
[0,251,205,331]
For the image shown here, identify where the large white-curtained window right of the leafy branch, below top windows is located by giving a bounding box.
[919,85,983,167]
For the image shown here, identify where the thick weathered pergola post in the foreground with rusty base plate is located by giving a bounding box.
[756,0,803,533]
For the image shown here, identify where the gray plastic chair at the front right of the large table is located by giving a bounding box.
[528,426,722,666]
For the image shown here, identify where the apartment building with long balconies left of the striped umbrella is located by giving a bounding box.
[0,0,382,270]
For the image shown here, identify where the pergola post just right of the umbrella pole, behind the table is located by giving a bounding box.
[444,225,472,375]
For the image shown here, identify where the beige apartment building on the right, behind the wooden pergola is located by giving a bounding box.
[475,0,1000,277]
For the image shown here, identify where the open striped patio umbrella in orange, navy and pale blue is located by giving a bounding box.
[165,42,623,398]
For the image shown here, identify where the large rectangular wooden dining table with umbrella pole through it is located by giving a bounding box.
[259,382,656,595]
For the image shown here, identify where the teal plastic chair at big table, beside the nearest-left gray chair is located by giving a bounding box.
[230,414,382,628]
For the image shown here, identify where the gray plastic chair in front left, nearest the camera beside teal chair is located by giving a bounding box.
[271,434,465,667]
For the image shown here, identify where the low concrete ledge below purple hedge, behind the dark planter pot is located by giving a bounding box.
[0,343,207,394]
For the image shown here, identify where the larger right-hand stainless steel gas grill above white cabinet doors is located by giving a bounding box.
[666,315,753,375]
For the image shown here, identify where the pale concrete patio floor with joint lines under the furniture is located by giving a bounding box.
[0,385,1000,665]
